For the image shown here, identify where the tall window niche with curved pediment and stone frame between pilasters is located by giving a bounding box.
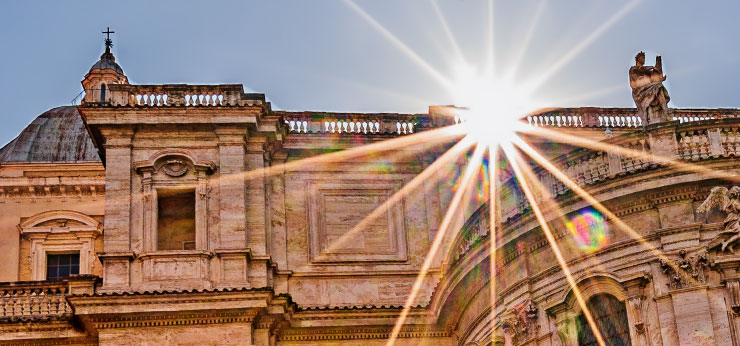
[134,153,215,253]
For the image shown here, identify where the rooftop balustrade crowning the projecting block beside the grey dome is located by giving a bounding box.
[91,84,264,107]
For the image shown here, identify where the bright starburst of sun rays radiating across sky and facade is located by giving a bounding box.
[336,0,648,346]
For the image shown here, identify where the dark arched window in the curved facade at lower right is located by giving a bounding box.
[577,294,631,346]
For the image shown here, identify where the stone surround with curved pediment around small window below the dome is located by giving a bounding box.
[18,210,103,280]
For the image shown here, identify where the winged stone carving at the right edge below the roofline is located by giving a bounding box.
[696,186,740,254]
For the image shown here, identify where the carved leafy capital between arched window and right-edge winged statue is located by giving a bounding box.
[660,250,709,289]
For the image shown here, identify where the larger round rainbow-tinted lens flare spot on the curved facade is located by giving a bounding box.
[565,208,609,251]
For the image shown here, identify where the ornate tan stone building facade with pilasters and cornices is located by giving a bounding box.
[0,41,740,346]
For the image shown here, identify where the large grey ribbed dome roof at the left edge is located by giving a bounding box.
[0,106,100,163]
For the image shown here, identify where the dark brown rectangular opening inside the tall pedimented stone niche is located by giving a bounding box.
[157,189,195,250]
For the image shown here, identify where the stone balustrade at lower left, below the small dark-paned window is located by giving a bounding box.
[0,281,72,320]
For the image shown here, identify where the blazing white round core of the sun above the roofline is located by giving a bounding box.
[452,64,537,148]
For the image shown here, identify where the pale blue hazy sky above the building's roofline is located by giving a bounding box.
[0,0,740,145]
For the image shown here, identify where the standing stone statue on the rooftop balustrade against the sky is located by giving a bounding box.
[630,52,671,124]
